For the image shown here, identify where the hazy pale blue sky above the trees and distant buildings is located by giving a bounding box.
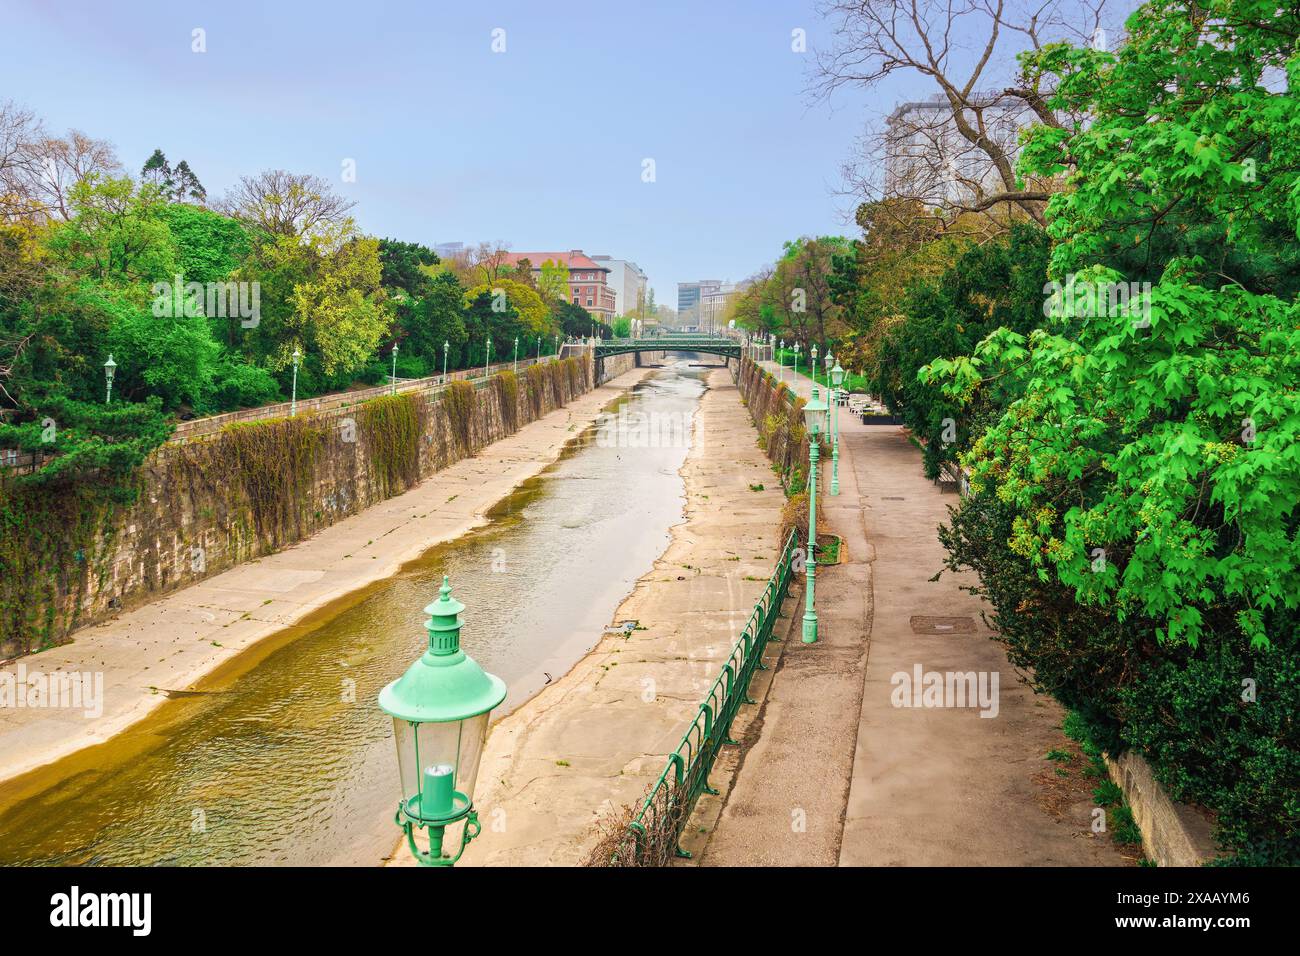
[0,0,904,306]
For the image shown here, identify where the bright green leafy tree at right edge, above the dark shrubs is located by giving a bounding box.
[931,0,1300,646]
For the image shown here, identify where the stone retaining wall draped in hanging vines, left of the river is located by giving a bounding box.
[0,355,603,659]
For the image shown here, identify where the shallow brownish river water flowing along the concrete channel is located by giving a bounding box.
[0,363,703,865]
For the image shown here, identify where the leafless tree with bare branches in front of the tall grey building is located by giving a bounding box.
[811,0,1123,226]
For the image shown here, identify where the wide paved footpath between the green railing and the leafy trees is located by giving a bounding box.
[701,365,1125,866]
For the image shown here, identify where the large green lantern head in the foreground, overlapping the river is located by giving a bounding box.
[380,576,506,866]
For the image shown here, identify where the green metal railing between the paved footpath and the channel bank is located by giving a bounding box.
[606,532,798,866]
